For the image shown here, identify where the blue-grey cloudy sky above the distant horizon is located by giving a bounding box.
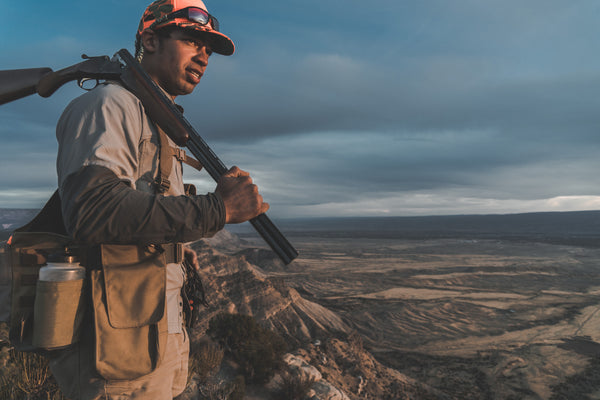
[0,0,600,218]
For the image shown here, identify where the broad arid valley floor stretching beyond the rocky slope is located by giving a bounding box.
[211,230,600,399]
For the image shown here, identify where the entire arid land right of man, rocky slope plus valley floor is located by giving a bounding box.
[3,223,600,400]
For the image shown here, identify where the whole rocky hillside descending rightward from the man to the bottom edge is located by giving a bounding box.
[184,231,443,400]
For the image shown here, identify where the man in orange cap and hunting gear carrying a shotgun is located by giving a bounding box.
[50,0,269,400]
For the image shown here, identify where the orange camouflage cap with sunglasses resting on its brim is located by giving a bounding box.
[137,0,235,56]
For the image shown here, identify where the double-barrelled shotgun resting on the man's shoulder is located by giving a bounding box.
[0,49,298,265]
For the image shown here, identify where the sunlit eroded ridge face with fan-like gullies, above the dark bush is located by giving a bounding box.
[192,234,351,346]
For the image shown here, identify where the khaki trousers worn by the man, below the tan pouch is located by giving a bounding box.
[50,329,189,400]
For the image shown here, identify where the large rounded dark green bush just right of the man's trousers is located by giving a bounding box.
[207,313,286,383]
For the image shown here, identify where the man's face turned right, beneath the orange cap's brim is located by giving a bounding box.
[147,30,212,98]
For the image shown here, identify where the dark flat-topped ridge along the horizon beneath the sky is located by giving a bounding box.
[231,211,600,246]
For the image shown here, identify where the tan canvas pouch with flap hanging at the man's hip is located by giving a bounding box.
[91,245,168,380]
